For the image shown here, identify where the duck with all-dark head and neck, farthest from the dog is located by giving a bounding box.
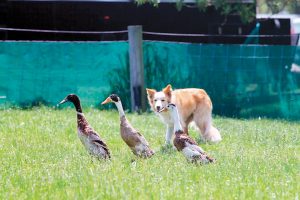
[59,94,111,160]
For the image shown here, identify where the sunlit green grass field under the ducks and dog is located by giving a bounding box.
[0,107,300,200]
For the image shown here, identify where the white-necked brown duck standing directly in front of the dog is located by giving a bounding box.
[160,103,215,164]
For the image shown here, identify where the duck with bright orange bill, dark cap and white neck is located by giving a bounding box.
[101,94,154,158]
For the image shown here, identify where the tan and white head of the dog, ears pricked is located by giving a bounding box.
[146,84,172,112]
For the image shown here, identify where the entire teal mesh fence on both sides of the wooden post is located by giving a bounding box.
[0,41,300,119]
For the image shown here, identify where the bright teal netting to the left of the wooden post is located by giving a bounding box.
[0,42,128,107]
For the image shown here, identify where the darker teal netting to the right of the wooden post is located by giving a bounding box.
[144,42,300,119]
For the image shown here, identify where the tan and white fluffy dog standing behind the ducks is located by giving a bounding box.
[146,84,222,144]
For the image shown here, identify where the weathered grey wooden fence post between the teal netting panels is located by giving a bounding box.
[128,26,146,112]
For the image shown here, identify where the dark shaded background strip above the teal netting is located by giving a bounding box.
[0,1,290,44]
